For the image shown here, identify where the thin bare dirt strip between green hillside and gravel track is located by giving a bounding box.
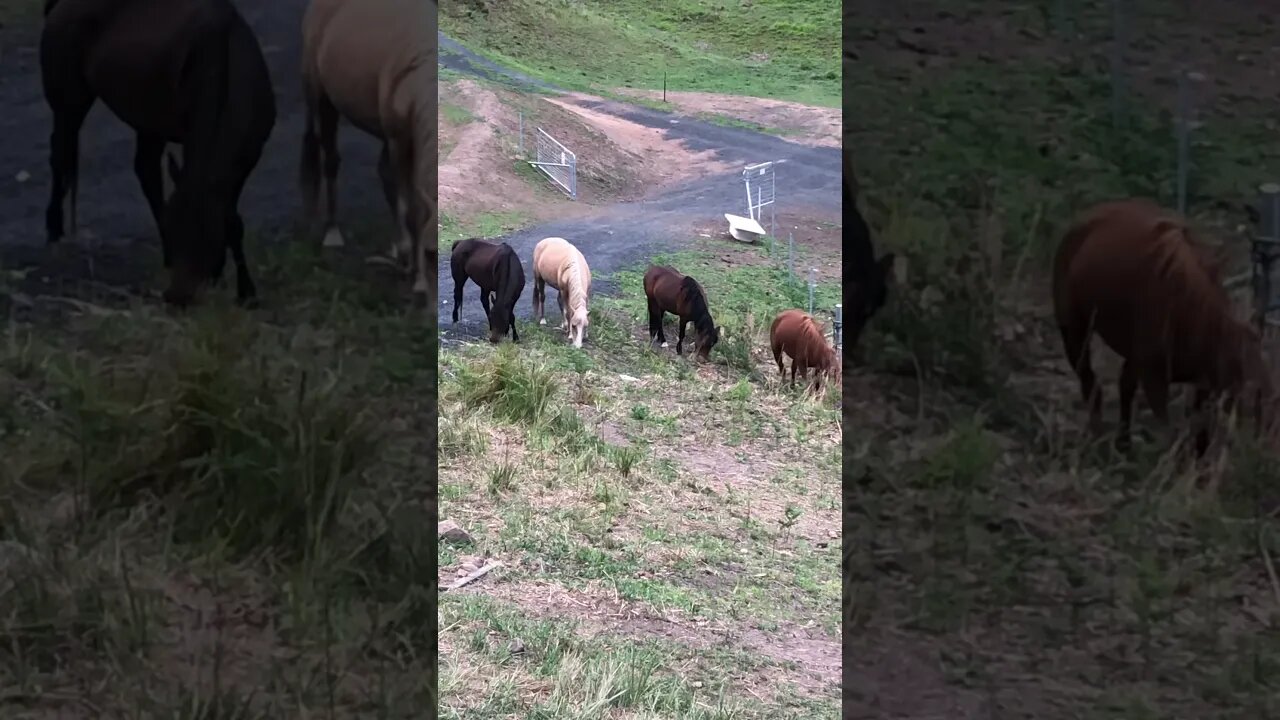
[614,87,841,147]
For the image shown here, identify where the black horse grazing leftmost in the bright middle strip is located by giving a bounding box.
[449,237,525,343]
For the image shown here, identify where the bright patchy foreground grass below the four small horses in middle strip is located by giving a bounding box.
[439,244,840,719]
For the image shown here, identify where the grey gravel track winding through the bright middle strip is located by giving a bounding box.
[439,28,841,342]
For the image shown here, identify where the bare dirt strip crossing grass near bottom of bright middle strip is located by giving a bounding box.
[458,580,841,696]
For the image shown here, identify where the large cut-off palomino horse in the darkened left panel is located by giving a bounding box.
[300,0,438,298]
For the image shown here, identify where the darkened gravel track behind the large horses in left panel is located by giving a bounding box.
[0,0,389,289]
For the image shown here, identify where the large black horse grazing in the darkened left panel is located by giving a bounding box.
[40,0,275,305]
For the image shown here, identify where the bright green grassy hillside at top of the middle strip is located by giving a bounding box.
[440,0,841,108]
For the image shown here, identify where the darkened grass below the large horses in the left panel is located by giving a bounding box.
[0,226,436,719]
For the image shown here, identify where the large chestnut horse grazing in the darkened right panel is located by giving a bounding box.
[1053,200,1274,456]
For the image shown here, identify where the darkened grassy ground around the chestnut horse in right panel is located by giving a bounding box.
[844,3,1280,720]
